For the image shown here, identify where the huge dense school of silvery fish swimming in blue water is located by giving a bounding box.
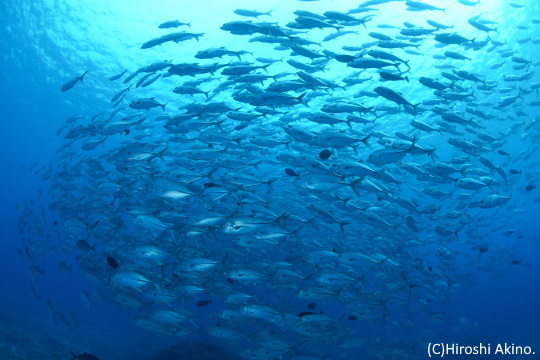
[19,0,540,360]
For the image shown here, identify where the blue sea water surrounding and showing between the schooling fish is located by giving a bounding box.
[0,0,540,360]
